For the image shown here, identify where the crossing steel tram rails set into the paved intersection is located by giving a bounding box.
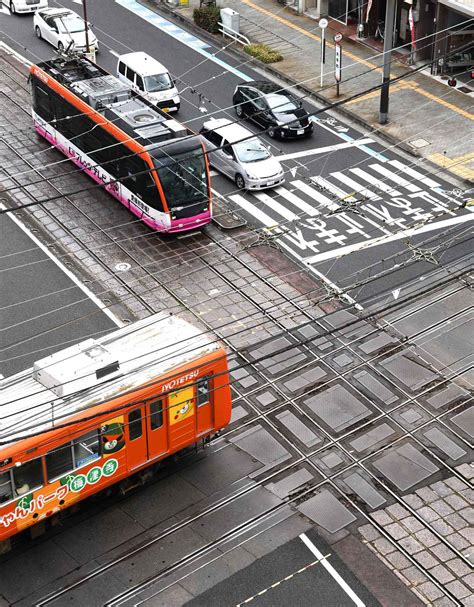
[1,60,472,605]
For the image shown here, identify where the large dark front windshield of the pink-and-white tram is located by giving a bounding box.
[155,147,208,209]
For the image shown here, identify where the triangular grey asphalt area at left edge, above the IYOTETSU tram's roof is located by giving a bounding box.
[0,215,117,377]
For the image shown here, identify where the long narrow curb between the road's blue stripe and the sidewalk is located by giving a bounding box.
[144,0,472,186]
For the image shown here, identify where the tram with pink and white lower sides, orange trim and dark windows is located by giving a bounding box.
[30,56,211,232]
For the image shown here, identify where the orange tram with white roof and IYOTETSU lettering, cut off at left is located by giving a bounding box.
[0,313,231,553]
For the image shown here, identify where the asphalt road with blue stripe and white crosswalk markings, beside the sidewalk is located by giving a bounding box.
[2,0,472,302]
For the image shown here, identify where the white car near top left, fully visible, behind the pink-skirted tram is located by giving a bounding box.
[33,8,99,53]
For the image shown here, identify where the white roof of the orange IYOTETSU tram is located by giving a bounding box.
[0,312,220,453]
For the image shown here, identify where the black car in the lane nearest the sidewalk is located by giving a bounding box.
[232,80,313,139]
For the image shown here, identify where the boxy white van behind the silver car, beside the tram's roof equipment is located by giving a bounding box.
[117,51,181,112]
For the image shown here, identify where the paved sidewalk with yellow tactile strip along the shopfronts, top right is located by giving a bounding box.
[152,0,474,184]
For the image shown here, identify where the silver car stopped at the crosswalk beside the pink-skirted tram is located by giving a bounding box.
[200,118,285,190]
